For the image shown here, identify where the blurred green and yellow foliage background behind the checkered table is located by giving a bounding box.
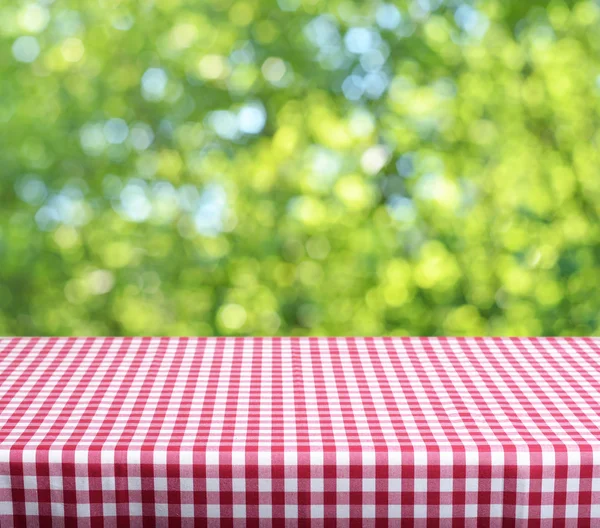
[0,0,600,335]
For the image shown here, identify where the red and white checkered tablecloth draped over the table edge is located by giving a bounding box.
[0,338,600,528]
